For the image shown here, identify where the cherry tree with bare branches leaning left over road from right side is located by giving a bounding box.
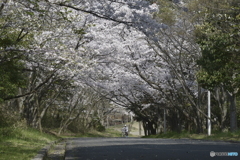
[68,0,204,134]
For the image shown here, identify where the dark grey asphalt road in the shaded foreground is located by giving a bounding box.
[65,138,240,160]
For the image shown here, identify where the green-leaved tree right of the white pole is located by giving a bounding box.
[196,0,240,131]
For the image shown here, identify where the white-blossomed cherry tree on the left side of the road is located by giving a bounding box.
[1,0,161,131]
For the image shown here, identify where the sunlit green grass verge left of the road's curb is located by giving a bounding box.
[0,128,58,160]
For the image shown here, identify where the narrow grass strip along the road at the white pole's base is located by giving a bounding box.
[143,131,240,141]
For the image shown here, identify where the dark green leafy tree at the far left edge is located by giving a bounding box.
[0,0,31,102]
